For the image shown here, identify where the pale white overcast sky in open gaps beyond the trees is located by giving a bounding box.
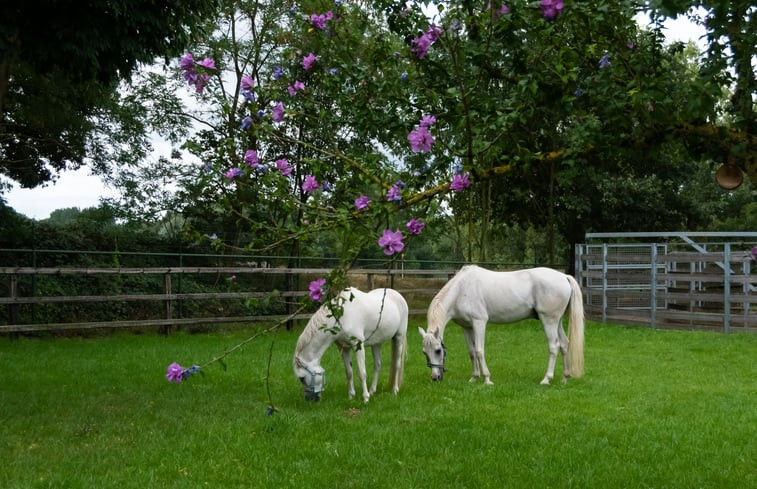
[3,13,704,219]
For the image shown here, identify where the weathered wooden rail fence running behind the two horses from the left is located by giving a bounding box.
[0,267,455,333]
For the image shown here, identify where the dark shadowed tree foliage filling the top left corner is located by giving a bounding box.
[0,0,216,188]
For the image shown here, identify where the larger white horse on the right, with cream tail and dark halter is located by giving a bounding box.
[418,265,584,384]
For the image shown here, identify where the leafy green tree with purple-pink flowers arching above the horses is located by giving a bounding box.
[136,0,752,300]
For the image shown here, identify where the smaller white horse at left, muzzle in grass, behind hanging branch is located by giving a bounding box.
[294,288,408,402]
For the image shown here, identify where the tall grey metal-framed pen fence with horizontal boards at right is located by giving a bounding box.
[576,233,757,333]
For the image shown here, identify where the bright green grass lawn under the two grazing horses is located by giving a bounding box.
[0,321,757,489]
